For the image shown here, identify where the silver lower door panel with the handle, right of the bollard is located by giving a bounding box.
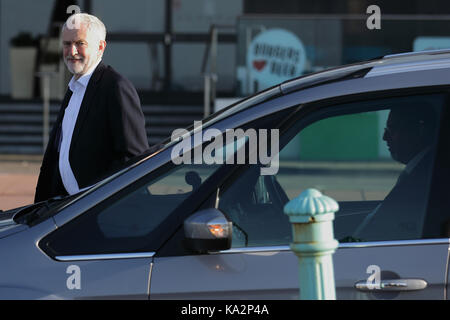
[333,239,449,300]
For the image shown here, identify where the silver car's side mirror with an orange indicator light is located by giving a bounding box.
[184,208,233,253]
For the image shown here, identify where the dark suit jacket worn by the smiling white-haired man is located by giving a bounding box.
[35,63,149,202]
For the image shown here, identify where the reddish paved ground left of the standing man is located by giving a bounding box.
[0,155,42,210]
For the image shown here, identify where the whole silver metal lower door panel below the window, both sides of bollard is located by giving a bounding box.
[150,239,448,300]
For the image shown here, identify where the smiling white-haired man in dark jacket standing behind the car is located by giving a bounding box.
[35,13,149,202]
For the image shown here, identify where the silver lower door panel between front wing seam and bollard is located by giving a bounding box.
[150,247,298,299]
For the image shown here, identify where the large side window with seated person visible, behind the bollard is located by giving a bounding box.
[219,94,444,247]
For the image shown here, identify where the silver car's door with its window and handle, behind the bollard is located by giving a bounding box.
[151,90,449,299]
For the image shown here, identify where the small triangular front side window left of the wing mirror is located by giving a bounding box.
[44,164,218,255]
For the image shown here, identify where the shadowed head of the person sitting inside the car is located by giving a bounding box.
[383,112,423,164]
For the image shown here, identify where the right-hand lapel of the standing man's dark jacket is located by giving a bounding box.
[70,62,106,149]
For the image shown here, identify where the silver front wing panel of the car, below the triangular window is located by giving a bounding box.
[0,214,152,299]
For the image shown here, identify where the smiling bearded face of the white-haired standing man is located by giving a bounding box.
[62,24,106,79]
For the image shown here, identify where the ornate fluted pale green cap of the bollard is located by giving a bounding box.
[284,189,339,223]
